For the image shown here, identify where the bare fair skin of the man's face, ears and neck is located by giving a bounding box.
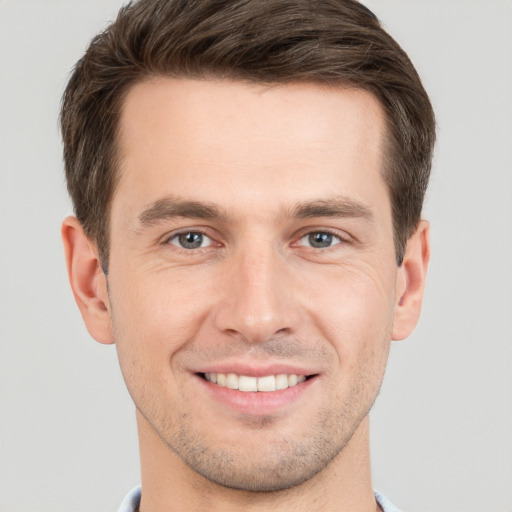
[63,78,429,512]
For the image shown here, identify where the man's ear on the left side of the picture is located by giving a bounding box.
[62,217,114,344]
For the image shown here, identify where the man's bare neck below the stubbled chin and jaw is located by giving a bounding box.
[137,413,378,512]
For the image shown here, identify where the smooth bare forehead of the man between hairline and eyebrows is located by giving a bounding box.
[114,78,385,220]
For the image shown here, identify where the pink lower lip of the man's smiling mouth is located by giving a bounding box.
[196,375,318,416]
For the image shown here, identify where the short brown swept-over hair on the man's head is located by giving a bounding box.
[61,0,435,267]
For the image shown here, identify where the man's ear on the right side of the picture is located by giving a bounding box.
[392,220,430,340]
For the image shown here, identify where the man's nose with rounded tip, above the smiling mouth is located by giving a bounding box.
[215,250,301,343]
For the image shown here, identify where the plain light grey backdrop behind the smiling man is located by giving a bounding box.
[0,0,512,512]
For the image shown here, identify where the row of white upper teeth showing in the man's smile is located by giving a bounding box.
[204,372,306,392]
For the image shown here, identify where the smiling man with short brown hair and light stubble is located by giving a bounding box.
[61,0,435,512]
